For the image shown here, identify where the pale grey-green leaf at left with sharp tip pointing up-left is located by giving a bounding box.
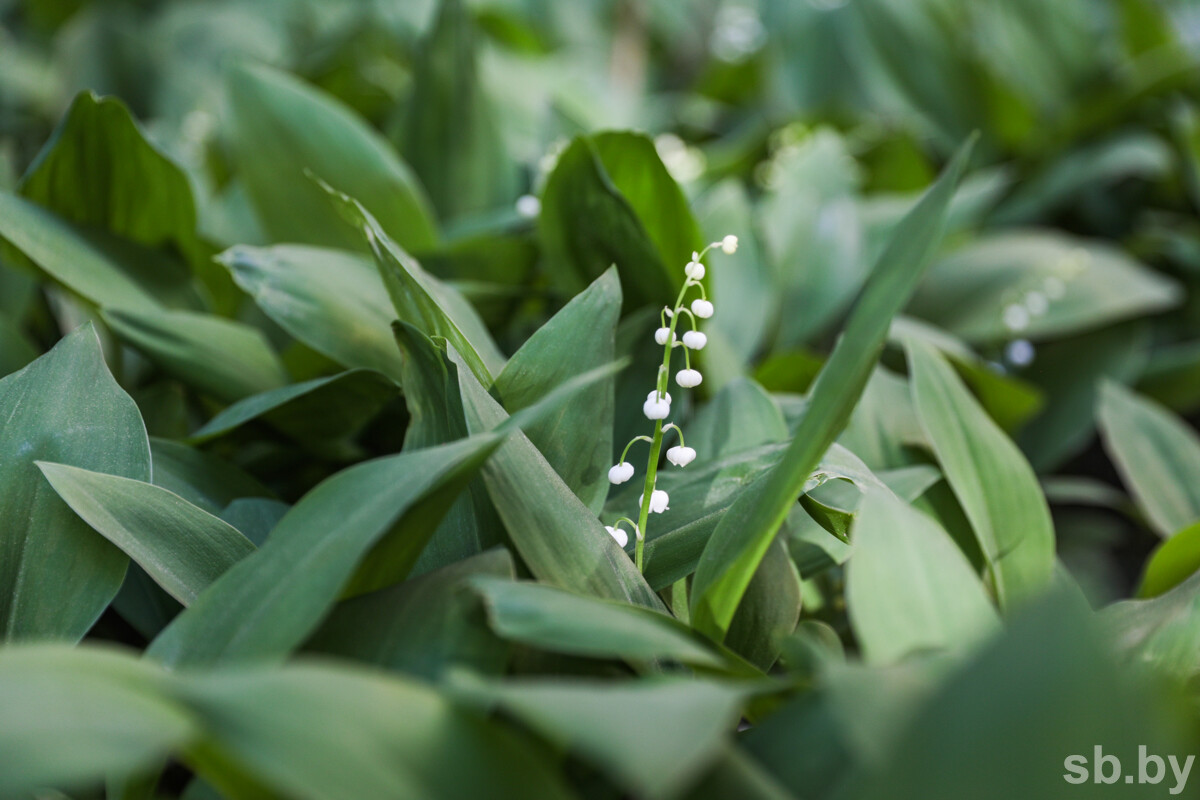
[37,462,254,606]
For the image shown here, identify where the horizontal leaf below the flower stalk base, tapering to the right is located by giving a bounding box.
[472,578,727,669]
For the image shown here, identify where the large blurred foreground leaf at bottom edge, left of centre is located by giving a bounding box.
[180,664,572,800]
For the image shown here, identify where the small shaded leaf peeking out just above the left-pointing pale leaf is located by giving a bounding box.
[150,438,271,515]
